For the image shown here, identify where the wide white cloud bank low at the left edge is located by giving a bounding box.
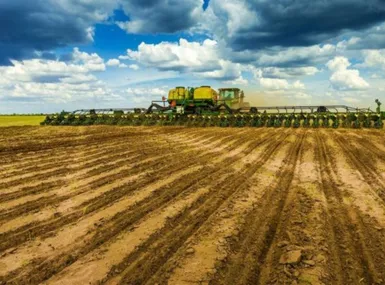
[0,48,114,102]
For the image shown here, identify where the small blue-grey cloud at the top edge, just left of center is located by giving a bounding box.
[117,0,203,33]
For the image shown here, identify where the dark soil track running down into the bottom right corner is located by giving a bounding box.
[316,133,384,284]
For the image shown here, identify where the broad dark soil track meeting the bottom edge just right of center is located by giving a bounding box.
[210,130,306,284]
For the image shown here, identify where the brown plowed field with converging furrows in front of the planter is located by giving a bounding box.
[0,126,385,285]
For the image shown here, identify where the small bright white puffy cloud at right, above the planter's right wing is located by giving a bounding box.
[326,56,369,90]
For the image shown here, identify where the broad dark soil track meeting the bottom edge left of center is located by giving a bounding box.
[97,132,288,284]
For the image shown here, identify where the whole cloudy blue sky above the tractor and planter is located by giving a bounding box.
[0,0,385,113]
